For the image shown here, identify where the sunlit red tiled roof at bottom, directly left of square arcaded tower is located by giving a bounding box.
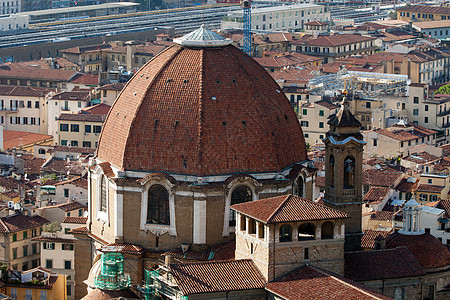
[170,259,266,296]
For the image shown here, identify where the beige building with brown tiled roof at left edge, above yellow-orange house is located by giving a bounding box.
[0,213,49,271]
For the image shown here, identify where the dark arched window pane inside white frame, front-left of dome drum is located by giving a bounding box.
[147,184,170,225]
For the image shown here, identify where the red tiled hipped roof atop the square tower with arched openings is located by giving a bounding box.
[231,195,349,223]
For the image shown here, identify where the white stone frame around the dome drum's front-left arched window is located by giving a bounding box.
[140,178,177,236]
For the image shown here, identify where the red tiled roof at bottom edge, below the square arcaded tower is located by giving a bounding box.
[266,265,391,300]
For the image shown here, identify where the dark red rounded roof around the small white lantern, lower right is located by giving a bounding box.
[386,232,450,269]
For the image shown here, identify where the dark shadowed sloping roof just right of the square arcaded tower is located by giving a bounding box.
[344,247,425,281]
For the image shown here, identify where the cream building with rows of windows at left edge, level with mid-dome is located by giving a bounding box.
[0,86,50,134]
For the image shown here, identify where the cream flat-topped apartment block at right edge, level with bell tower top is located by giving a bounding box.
[406,84,450,146]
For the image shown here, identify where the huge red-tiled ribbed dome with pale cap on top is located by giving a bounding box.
[97,28,307,176]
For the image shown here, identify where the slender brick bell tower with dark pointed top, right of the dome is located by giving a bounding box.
[324,90,365,251]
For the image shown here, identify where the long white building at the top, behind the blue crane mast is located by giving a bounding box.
[220,3,331,31]
